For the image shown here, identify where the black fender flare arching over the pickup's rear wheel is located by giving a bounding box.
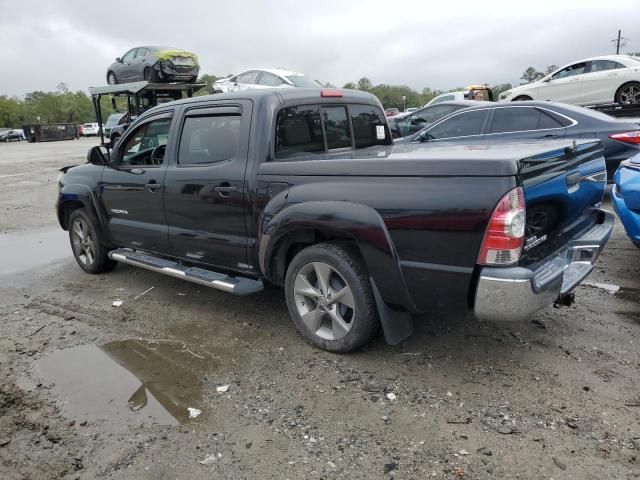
[258,201,415,311]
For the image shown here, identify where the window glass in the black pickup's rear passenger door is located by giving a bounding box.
[178,115,241,165]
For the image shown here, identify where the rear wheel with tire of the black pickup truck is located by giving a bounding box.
[285,243,380,353]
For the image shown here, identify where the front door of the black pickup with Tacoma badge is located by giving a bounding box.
[99,111,173,253]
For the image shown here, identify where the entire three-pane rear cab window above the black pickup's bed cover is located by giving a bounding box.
[274,103,392,160]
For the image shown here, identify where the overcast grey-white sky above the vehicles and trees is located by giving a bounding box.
[0,0,640,95]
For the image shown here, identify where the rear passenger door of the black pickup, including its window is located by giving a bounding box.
[165,101,251,270]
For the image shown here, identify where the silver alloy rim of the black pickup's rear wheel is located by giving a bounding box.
[294,262,356,340]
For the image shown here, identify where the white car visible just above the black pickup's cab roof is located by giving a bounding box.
[213,68,322,93]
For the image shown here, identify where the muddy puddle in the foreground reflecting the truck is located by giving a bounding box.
[33,340,217,430]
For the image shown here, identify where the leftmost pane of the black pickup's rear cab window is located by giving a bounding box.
[275,105,324,158]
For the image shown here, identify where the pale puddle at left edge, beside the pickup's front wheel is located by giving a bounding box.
[0,228,73,277]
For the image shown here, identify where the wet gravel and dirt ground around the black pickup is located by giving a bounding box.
[0,139,640,480]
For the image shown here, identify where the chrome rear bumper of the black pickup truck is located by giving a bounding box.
[473,211,614,321]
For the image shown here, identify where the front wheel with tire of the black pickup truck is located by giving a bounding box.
[67,208,118,274]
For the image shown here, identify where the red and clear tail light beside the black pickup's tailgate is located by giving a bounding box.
[478,187,526,265]
